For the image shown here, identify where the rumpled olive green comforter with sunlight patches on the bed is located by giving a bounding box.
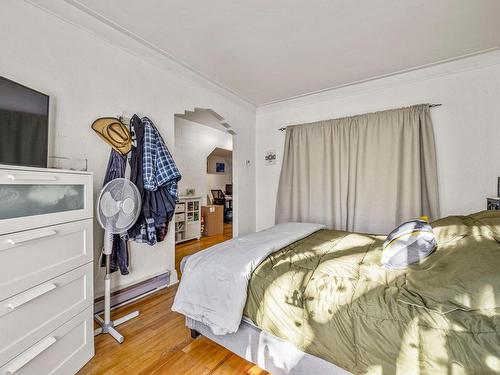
[244,211,500,375]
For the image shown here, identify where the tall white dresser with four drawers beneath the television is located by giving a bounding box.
[0,165,94,375]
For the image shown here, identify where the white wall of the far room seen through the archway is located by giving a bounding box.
[175,117,233,204]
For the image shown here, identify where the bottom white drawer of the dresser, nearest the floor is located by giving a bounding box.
[0,308,94,375]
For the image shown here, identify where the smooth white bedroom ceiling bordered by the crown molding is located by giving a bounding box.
[45,0,500,105]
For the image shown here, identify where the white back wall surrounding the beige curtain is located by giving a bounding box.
[256,51,500,230]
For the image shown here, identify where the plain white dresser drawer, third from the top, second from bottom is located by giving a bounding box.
[0,263,93,364]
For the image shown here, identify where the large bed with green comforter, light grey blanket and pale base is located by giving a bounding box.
[174,211,500,375]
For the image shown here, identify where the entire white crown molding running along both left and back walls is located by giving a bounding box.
[21,0,500,114]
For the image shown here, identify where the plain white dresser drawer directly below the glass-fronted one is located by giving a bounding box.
[0,219,93,301]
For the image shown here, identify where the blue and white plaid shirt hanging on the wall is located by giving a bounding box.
[142,117,181,201]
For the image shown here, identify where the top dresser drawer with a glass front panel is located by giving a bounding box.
[0,168,93,234]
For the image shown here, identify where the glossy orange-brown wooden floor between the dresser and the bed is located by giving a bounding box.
[78,226,268,375]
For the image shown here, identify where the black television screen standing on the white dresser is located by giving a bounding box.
[0,77,49,167]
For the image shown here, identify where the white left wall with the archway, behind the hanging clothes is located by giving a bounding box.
[0,0,255,293]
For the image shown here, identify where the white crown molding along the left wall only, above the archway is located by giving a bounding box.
[25,0,257,112]
